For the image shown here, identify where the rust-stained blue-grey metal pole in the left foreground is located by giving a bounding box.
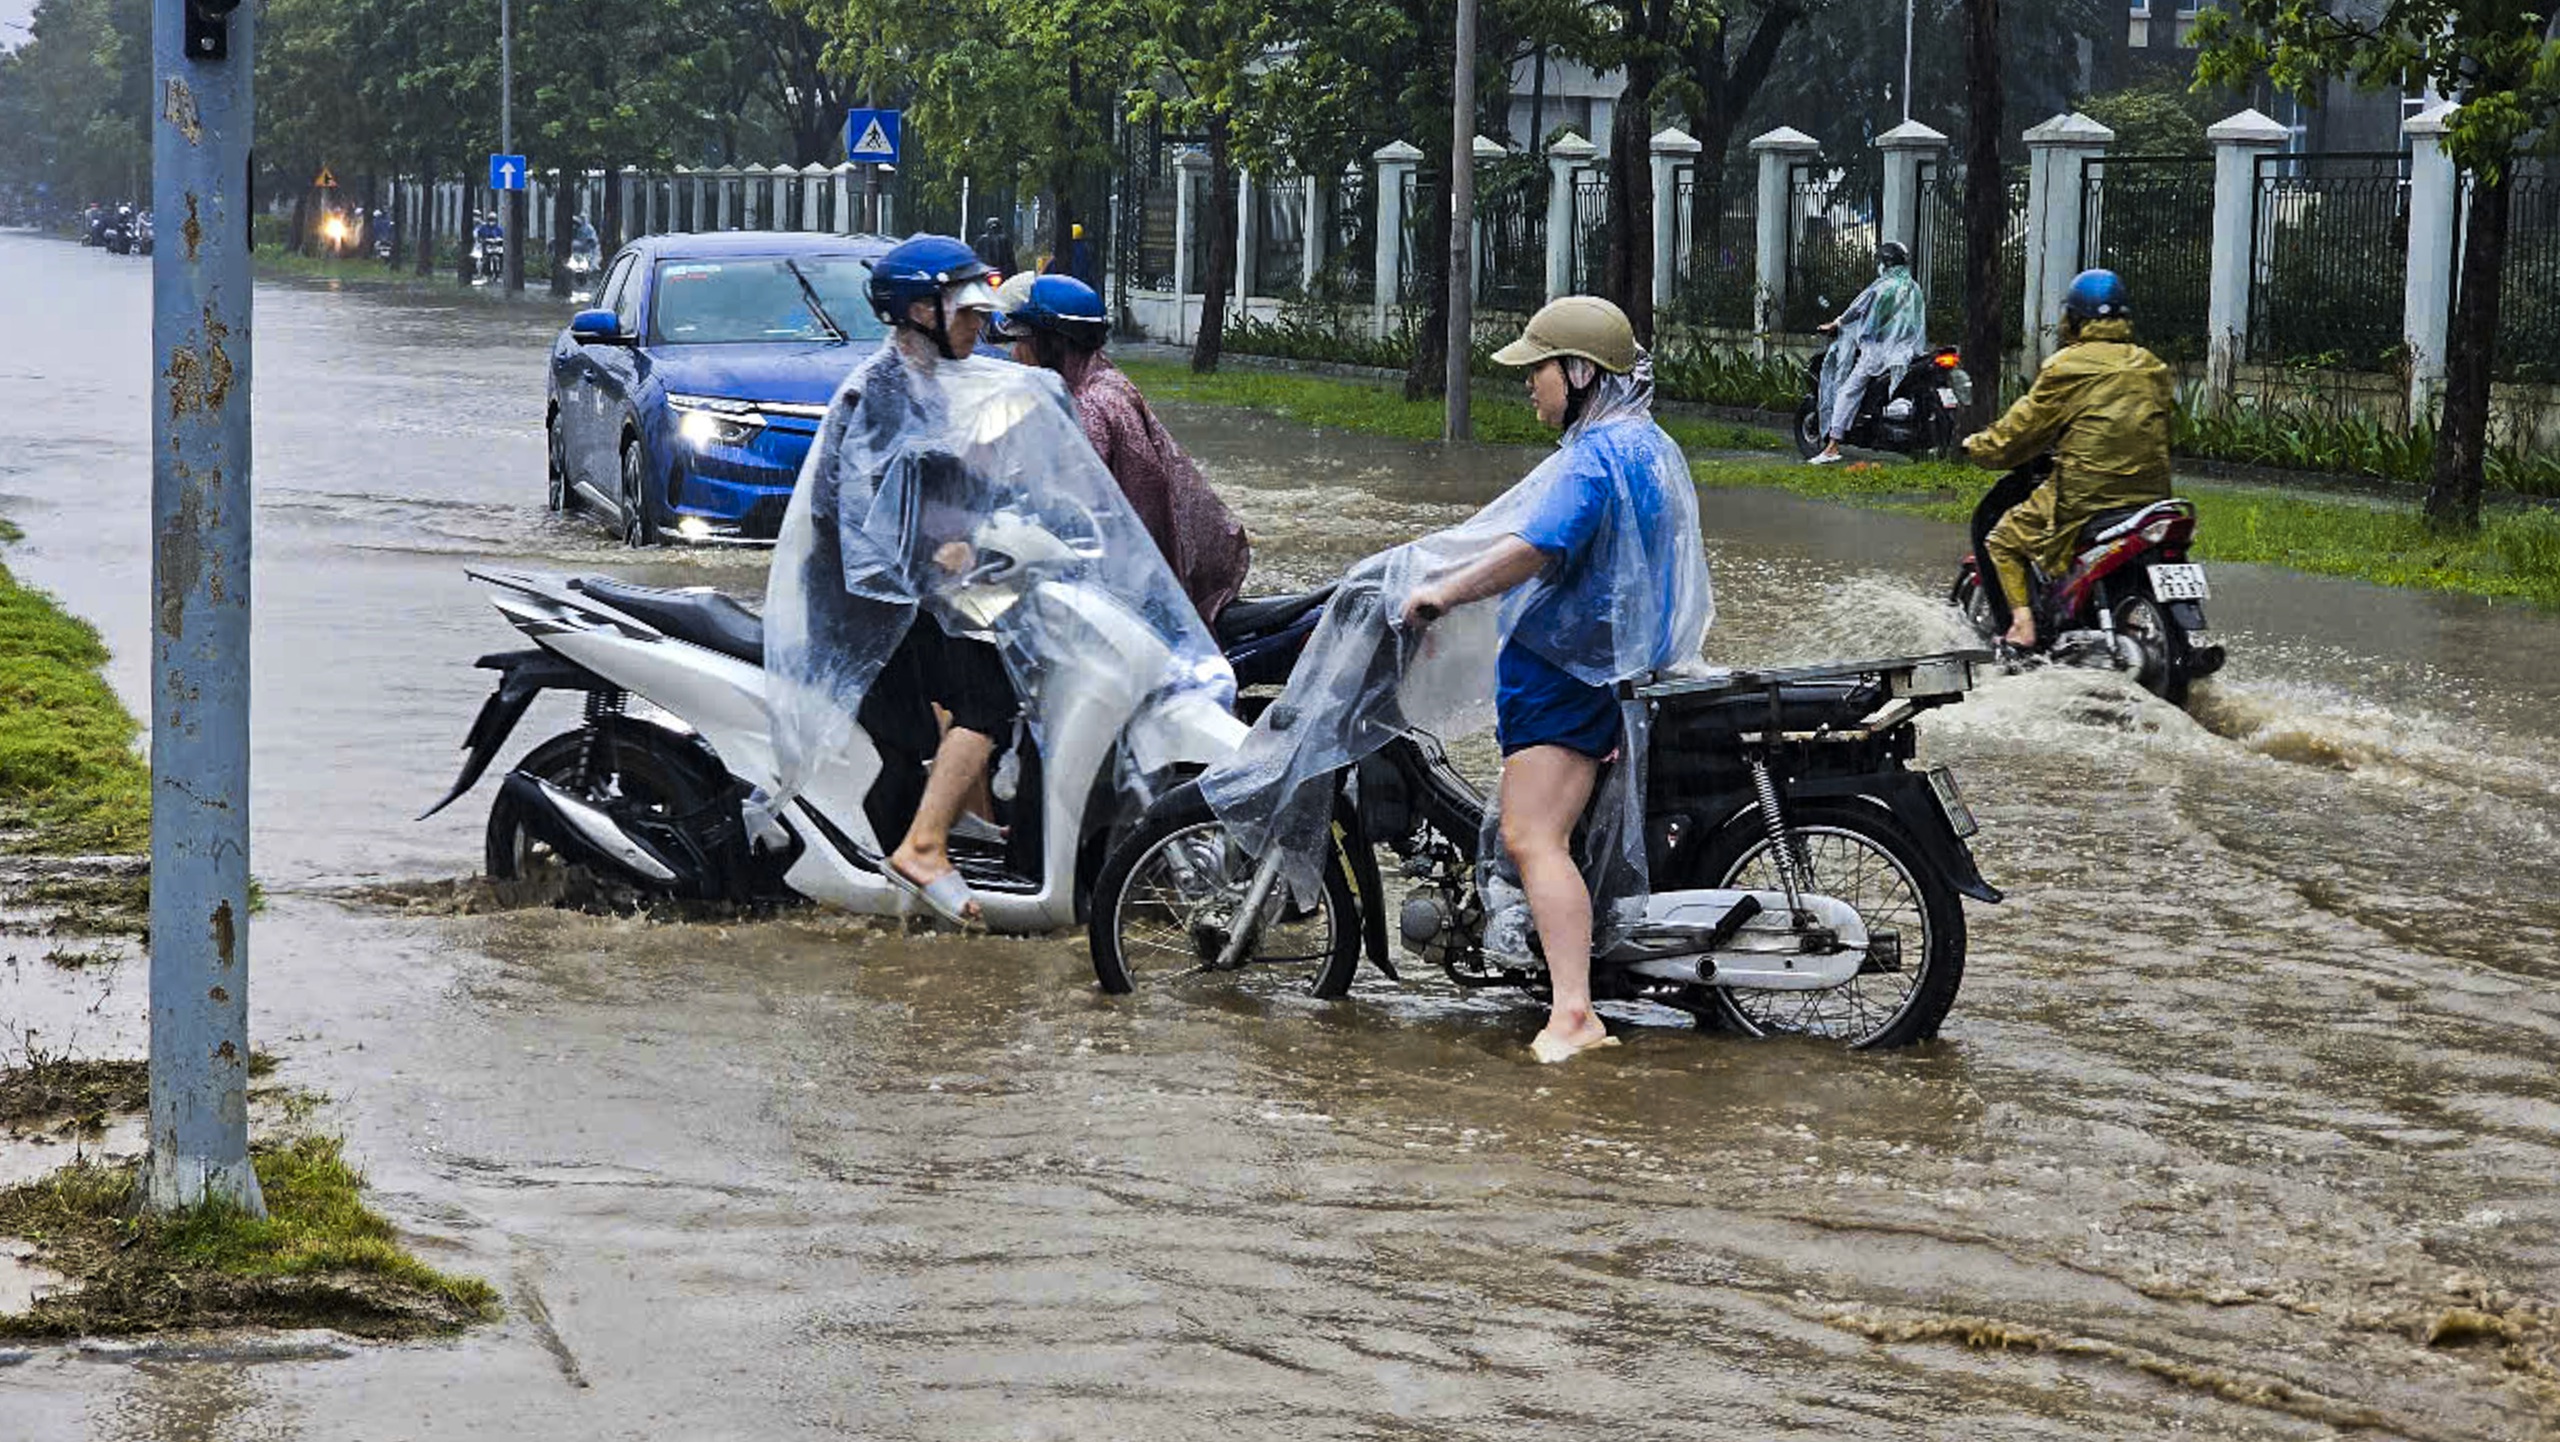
[143,0,266,1217]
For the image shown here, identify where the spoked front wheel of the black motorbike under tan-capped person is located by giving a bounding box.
[1088,786,1359,999]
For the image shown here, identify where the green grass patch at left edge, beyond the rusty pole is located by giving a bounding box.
[0,545,151,855]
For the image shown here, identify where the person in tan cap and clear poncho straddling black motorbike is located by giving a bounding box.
[1201,297,1715,1060]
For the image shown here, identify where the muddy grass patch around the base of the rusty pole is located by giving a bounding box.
[0,1135,499,1337]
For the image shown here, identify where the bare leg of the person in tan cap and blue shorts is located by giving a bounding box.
[1503,745,1608,1055]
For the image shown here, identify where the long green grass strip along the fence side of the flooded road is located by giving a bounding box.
[1121,361,2560,607]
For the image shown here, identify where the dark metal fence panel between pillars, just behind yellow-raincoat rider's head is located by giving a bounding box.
[2079,156,2214,361]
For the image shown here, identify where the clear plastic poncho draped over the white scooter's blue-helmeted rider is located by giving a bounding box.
[753,336,1236,845]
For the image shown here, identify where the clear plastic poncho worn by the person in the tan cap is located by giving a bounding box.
[1201,361,1715,955]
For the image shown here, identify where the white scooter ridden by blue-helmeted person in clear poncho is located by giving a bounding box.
[428,512,1254,935]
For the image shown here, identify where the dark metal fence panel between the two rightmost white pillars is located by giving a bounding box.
[2248,151,2409,371]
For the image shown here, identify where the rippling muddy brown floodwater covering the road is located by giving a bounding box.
[0,236,2560,1439]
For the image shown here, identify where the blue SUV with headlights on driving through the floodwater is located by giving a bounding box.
[545,231,893,546]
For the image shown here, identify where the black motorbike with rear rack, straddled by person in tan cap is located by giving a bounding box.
[1088,583,1999,1048]
